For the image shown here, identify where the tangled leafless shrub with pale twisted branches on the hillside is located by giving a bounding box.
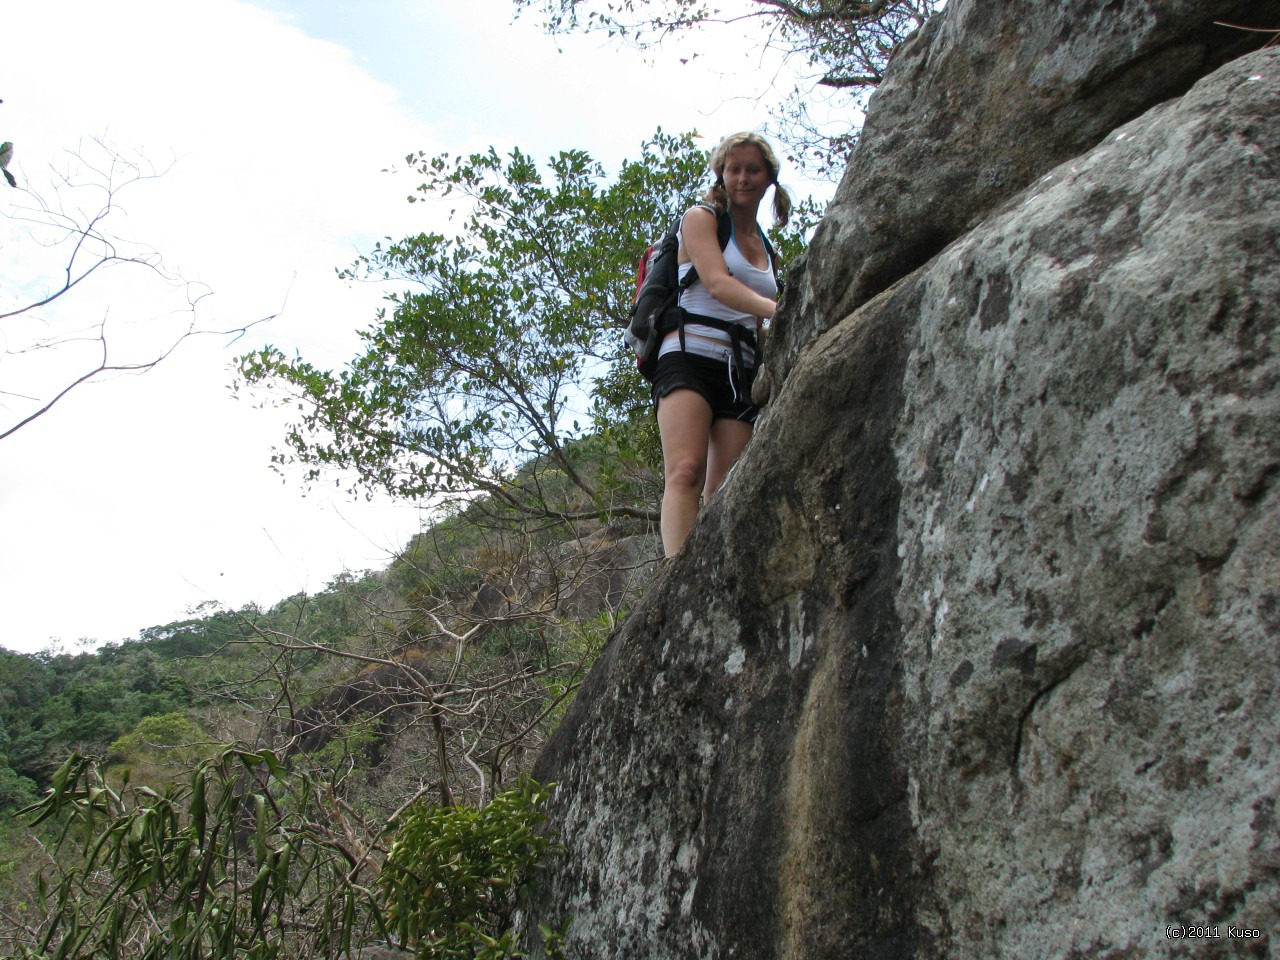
[248,554,585,805]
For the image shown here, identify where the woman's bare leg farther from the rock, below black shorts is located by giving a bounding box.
[658,390,712,557]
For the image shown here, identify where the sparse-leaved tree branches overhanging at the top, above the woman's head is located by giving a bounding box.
[515,0,946,177]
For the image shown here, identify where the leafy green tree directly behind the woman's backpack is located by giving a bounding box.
[241,131,815,522]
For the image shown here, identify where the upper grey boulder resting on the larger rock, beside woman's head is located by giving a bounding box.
[759,0,1280,394]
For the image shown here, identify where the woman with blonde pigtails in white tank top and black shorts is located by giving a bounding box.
[653,133,791,557]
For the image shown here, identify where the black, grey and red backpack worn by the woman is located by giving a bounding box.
[622,207,777,383]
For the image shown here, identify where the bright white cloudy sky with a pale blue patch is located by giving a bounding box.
[0,0,829,652]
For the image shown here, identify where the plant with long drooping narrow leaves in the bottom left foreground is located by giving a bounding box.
[18,749,380,960]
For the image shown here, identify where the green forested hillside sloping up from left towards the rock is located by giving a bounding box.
[0,477,655,956]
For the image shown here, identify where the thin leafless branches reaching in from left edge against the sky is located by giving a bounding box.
[0,140,269,440]
